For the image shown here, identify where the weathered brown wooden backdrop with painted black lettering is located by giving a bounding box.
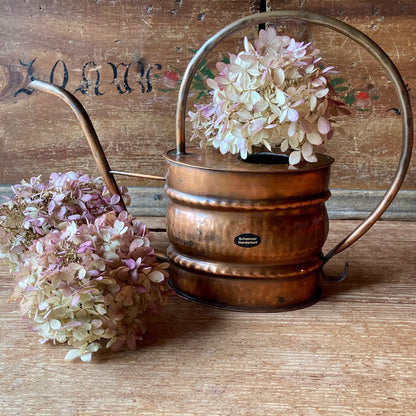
[0,0,416,218]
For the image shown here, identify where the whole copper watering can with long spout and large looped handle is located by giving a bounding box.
[29,11,413,311]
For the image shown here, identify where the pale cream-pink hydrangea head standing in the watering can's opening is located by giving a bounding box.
[189,27,347,165]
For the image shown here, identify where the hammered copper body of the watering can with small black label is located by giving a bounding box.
[165,147,332,310]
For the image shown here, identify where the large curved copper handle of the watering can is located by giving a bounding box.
[176,11,413,264]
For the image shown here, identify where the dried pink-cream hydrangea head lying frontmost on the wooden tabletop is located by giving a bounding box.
[12,211,170,361]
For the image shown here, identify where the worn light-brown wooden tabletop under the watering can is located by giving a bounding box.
[0,219,416,416]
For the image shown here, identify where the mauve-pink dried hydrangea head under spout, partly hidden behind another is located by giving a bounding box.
[0,172,130,270]
